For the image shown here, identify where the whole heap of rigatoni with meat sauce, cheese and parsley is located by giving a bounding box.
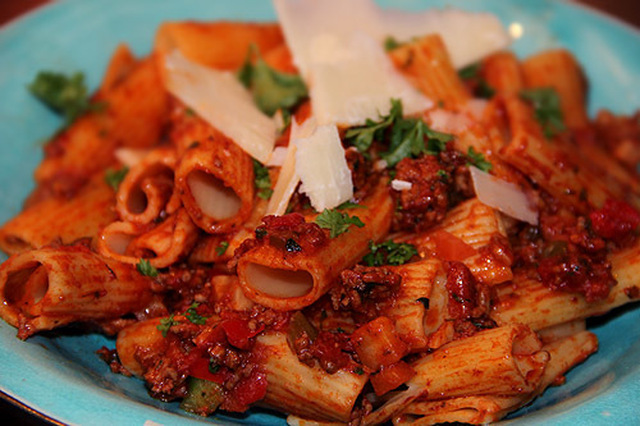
[0,0,640,425]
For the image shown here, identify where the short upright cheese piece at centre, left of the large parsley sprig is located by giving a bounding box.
[293,120,353,212]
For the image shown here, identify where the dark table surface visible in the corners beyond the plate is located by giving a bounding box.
[0,0,640,426]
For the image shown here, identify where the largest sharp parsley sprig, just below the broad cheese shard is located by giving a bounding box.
[345,99,453,167]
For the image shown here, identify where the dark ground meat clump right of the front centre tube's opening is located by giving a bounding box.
[330,265,402,322]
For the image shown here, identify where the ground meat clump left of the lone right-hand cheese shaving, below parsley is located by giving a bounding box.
[392,148,473,232]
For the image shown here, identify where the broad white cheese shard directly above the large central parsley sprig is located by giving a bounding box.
[309,33,433,126]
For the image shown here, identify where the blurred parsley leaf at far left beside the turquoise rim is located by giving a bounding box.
[27,71,104,125]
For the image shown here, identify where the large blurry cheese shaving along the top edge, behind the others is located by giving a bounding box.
[274,0,511,79]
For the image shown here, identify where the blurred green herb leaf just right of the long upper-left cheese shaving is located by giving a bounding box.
[237,44,307,116]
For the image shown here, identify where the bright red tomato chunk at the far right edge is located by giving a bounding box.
[589,198,640,242]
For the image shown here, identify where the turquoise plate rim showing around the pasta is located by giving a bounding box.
[0,0,640,426]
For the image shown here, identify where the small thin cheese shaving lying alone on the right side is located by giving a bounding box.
[469,167,538,225]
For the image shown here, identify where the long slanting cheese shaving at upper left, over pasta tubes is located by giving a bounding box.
[164,50,277,163]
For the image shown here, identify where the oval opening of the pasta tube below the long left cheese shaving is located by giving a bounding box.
[187,170,242,220]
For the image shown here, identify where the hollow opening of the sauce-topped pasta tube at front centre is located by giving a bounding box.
[246,263,313,297]
